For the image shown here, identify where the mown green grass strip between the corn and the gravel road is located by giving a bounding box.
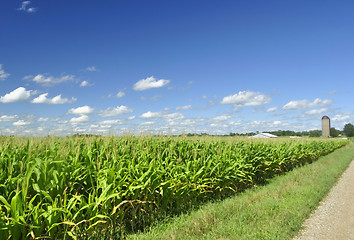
[127,143,354,239]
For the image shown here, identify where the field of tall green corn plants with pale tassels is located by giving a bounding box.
[0,136,347,240]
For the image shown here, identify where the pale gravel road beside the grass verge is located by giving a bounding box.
[293,158,354,240]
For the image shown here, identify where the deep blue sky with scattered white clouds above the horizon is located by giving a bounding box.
[0,0,354,135]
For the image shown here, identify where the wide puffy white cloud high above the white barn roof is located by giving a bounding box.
[221,91,271,108]
